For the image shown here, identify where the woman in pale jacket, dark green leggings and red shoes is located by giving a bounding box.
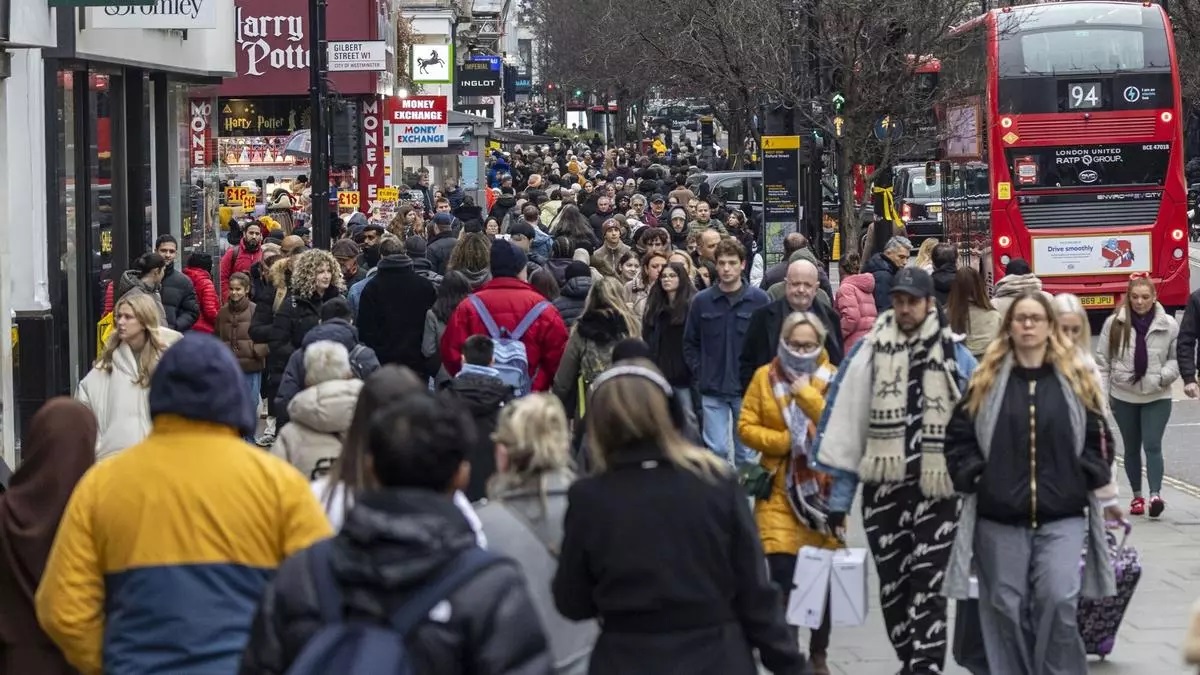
[1096,274,1180,518]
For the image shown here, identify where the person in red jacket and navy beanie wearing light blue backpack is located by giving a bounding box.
[442,239,566,396]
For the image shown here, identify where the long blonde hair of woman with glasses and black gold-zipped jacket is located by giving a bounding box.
[966,291,1104,416]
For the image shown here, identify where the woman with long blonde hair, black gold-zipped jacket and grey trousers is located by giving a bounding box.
[942,293,1121,675]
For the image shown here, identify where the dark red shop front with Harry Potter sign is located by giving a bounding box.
[190,0,396,228]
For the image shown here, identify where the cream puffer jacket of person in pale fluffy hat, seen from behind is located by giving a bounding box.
[271,380,362,480]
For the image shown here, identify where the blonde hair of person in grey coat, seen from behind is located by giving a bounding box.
[487,393,574,500]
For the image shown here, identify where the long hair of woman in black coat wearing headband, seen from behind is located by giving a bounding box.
[587,359,728,480]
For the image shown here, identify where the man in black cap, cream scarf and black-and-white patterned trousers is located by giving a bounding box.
[810,267,976,673]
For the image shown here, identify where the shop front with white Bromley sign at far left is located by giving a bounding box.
[11,2,234,446]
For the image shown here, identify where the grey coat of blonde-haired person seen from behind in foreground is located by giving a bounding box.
[476,471,600,675]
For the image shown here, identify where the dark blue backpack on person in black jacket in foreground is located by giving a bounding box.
[287,539,502,675]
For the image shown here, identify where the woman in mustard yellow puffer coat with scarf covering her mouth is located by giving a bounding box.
[738,312,842,675]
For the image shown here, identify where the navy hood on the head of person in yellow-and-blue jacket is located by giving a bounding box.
[150,333,258,436]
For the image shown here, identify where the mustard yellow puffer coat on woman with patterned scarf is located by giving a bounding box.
[738,353,842,555]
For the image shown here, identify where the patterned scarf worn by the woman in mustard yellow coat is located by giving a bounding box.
[767,341,834,533]
